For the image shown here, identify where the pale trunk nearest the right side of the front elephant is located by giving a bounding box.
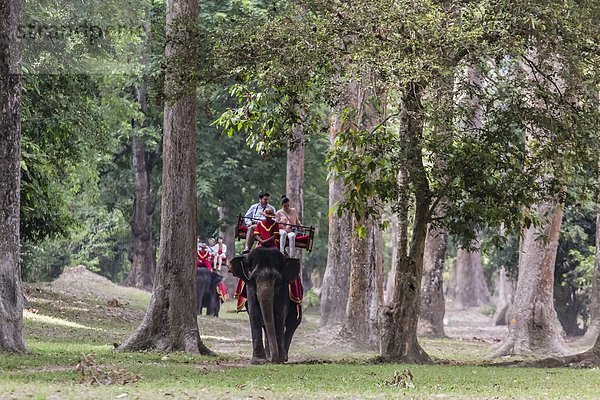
[320,112,353,327]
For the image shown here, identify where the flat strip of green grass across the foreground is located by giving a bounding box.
[0,342,600,399]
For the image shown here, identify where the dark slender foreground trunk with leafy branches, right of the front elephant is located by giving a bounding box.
[381,82,431,363]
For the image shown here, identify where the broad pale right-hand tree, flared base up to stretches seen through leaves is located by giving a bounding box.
[494,47,567,356]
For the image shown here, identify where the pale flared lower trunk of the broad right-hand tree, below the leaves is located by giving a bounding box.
[494,202,567,356]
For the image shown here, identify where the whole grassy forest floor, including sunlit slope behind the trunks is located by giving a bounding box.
[0,268,600,399]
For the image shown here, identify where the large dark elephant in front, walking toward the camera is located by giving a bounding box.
[231,247,302,364]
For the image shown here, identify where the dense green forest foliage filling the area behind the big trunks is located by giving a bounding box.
[8,0,599,364]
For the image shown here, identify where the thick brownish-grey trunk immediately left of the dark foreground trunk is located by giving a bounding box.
[341,219,383,349]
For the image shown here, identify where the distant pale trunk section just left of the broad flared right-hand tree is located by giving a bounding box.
[454,245,490,307]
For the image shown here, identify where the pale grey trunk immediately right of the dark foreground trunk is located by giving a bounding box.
[419,229,448,338]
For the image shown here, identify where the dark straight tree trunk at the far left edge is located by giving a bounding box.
[0,0,27,351]
